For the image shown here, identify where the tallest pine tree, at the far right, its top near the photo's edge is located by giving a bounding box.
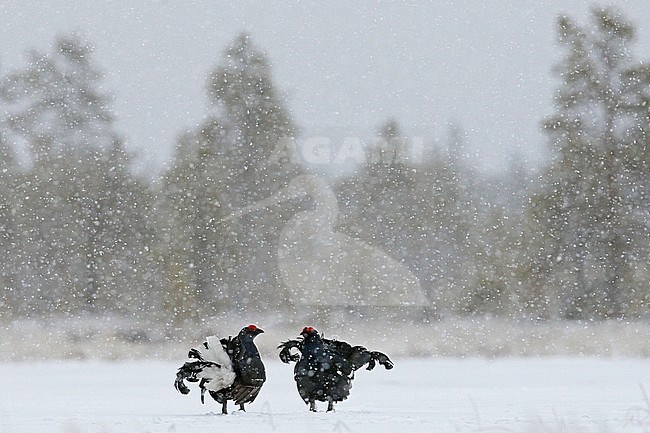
[530,5,648,318]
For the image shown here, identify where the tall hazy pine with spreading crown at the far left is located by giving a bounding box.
[0,35,156,311]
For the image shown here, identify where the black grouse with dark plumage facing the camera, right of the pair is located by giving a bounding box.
[278,326,393,412]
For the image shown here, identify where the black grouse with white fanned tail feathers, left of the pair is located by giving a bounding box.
[174,325,266,414]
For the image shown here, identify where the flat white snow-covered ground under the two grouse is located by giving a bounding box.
[0,357,650,433]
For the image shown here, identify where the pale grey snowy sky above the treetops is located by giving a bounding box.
[0,0,650,172]
